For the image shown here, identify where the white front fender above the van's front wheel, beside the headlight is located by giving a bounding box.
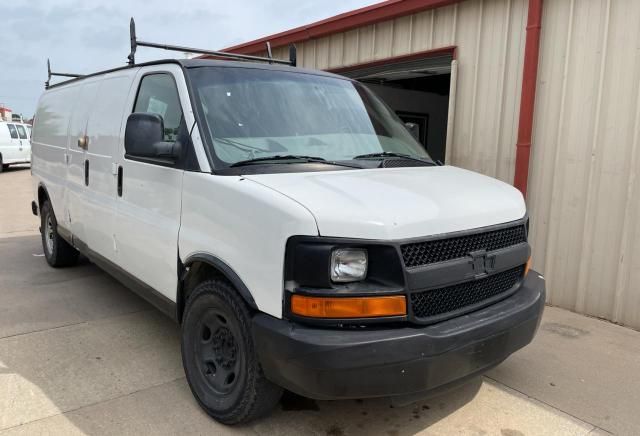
[179,172,318,317]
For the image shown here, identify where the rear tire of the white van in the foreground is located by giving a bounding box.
[40,200,80,268]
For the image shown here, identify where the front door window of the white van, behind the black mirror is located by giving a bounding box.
[133,73,182,142]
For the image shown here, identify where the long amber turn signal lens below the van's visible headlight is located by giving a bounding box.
[291,295,407,318]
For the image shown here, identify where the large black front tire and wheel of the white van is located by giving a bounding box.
[181,280,282,425]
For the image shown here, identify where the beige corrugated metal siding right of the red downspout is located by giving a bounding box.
[529,0,640,327]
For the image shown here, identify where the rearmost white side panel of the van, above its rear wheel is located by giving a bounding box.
[31,86,80,229]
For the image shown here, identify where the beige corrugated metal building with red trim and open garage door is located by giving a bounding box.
[227,0,640,328]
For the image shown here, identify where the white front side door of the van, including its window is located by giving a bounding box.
[115,65,184,299]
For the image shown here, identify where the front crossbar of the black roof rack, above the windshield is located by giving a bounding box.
[127,17,297,67]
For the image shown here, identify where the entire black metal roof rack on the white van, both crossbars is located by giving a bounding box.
[44,17,297,89]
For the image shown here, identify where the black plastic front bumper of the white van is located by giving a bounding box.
[253,271,545,399]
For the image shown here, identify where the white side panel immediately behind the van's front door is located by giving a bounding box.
[81,70,135,262]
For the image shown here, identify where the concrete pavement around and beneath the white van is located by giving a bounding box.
[0,165,640,436]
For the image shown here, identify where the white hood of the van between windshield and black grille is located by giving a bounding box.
[244,166,526,240]
